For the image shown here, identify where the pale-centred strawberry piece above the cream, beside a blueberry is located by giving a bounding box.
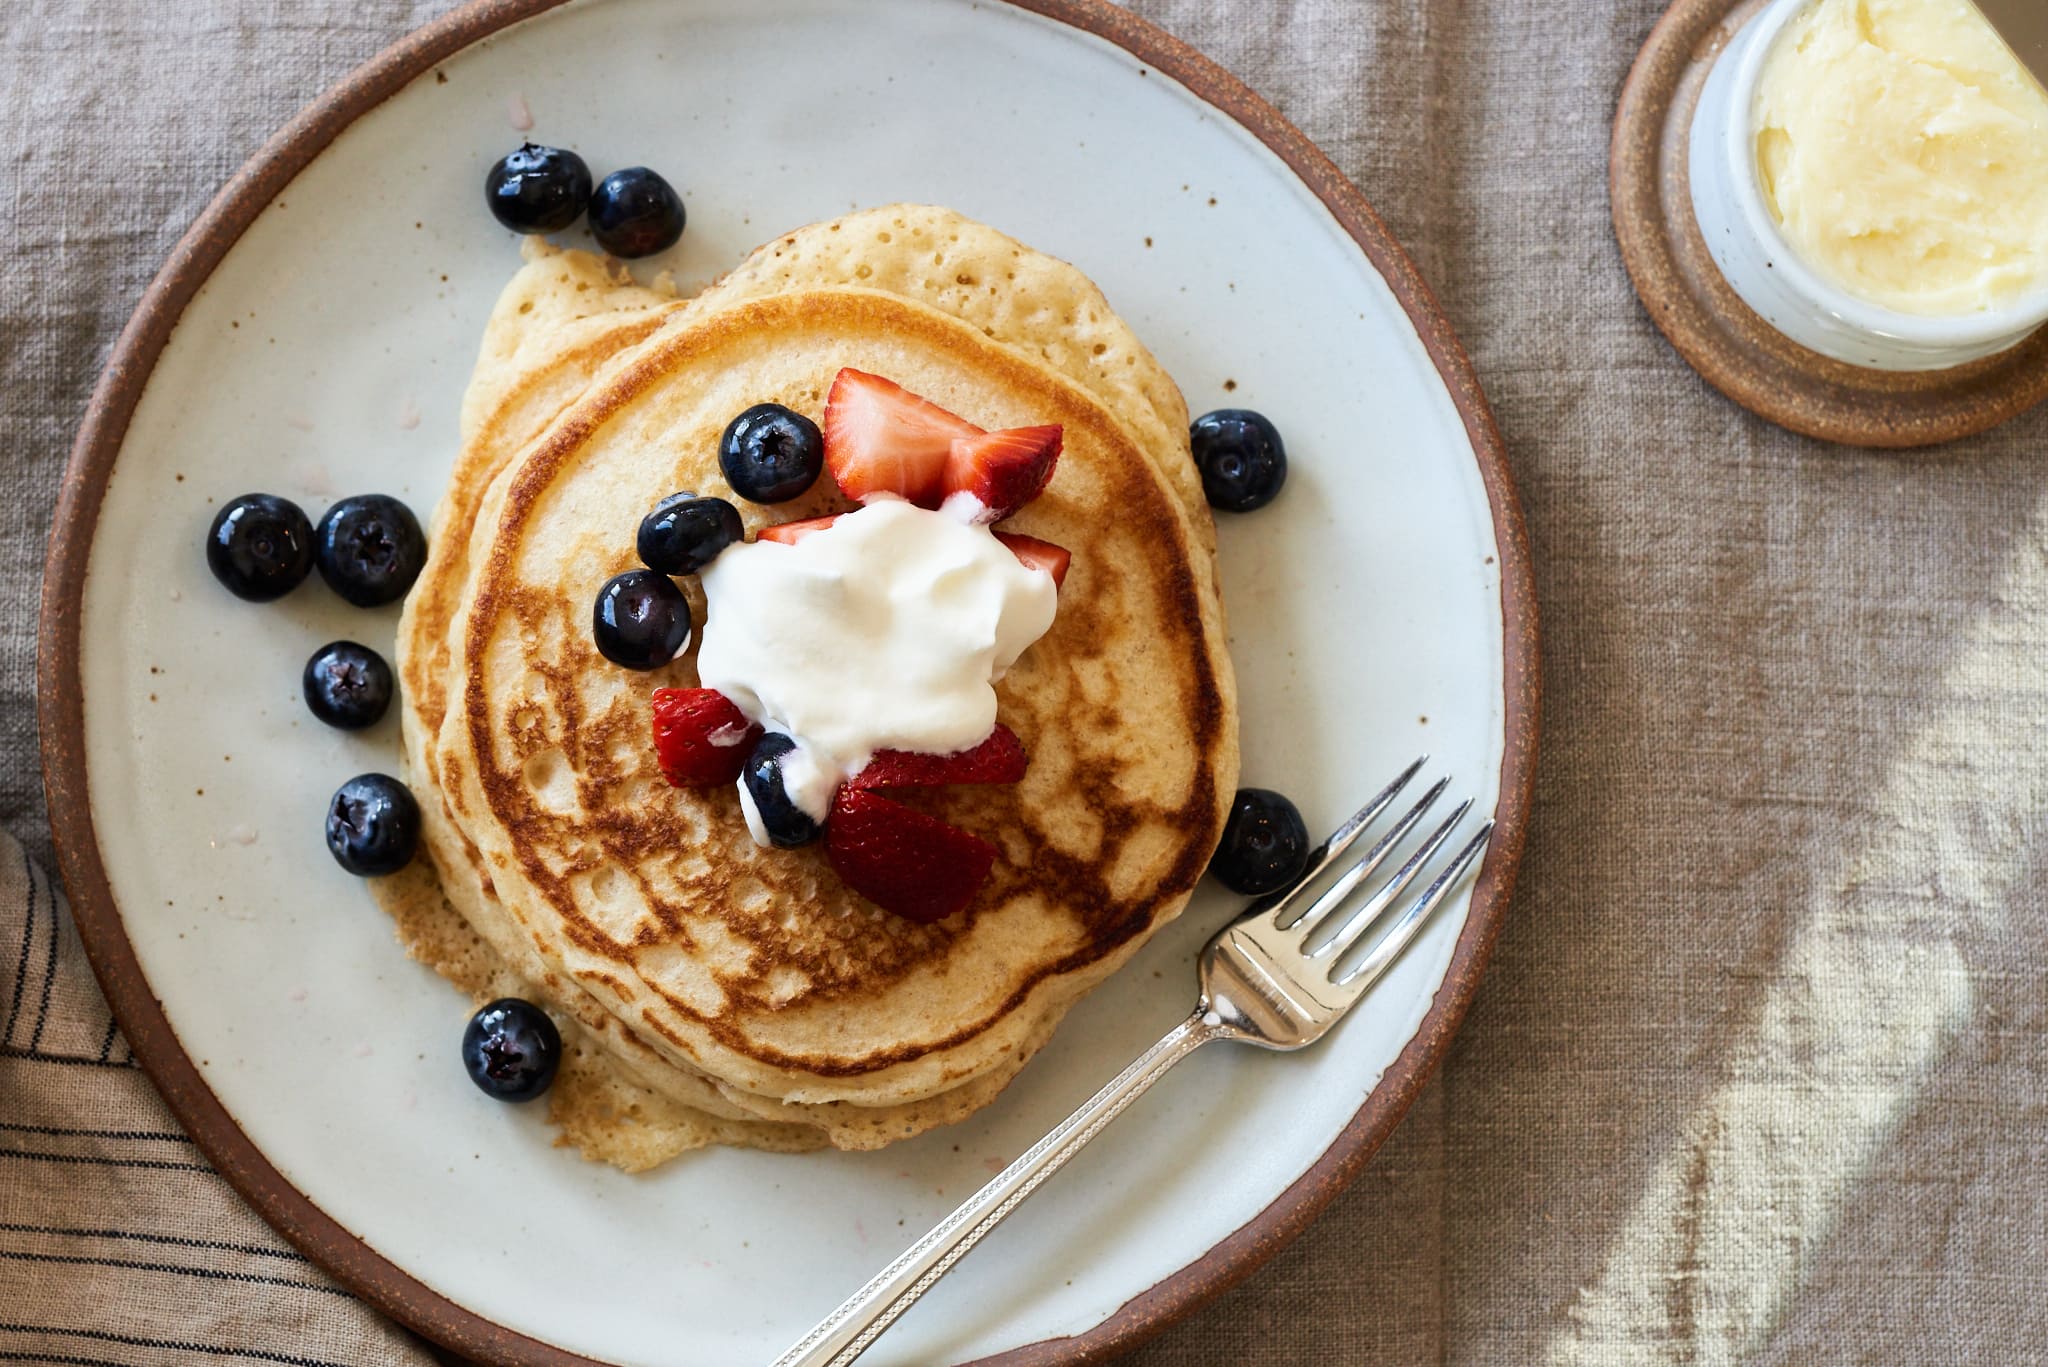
[823,367,981,508]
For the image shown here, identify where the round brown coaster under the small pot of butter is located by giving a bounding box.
[1608,0,2048,447]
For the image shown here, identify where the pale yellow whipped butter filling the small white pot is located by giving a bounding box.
[1755,0,2048,316]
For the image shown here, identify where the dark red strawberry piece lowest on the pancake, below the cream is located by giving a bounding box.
[825,787,995,926]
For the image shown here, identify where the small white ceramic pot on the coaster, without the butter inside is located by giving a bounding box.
[1688,0,2048,371]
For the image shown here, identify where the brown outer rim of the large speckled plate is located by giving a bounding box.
[37,0,1540,1367]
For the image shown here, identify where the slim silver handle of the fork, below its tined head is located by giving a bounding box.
[774,1010,1229,1367]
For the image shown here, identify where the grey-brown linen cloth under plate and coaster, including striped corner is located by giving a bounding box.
[0,0,2048,1367]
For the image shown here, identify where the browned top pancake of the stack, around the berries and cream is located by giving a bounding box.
[438,291,1235,1092]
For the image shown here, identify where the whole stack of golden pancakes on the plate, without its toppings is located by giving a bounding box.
[377,205,1237,1170]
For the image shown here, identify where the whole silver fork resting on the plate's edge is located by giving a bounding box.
[774,756,1493,1367]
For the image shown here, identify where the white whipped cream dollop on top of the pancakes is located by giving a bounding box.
[696,498,1059,844]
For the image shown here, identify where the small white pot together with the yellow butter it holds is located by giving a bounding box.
[1690,0,2048,371]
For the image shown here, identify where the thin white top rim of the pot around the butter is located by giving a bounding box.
[1696,0,2048,353]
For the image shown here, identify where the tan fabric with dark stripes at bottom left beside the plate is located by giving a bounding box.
[0,834,434,1367]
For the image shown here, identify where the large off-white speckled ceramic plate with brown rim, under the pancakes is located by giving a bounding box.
[43,0,1534,1367]
